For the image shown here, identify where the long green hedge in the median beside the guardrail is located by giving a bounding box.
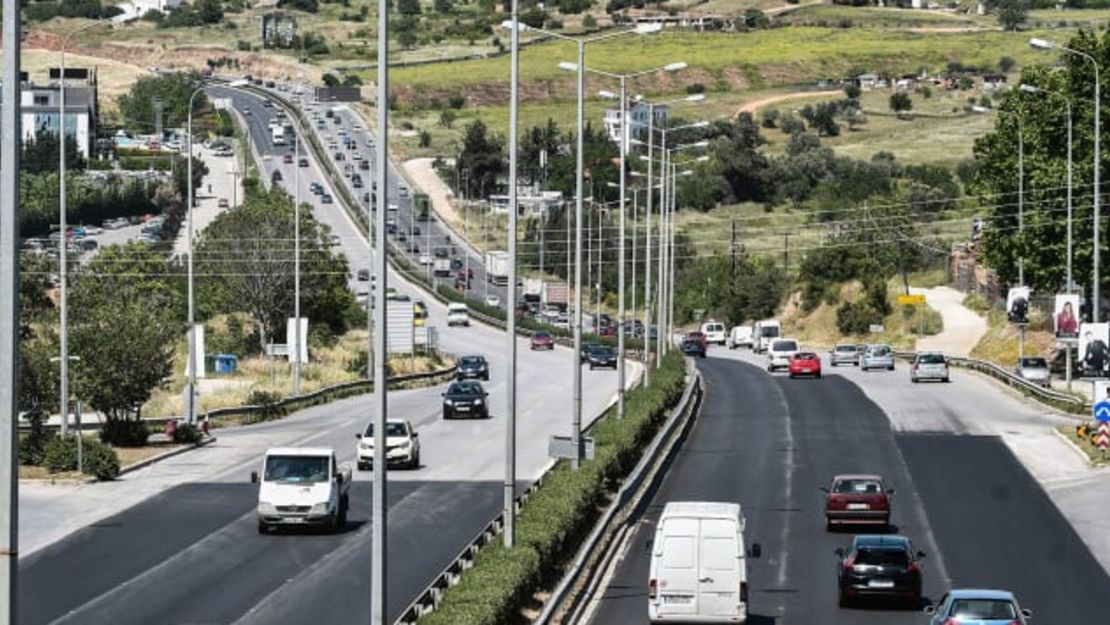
[420,352,686,625]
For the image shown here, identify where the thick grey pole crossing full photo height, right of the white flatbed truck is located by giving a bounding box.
[370,0,390,625]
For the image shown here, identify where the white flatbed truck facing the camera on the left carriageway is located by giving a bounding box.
[251,447,351,534]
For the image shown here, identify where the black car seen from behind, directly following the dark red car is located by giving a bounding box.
[836,535,925,607]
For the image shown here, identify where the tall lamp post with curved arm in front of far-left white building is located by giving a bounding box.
[58,20,102,437]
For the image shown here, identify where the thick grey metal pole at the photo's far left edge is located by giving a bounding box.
[0,0,22,625]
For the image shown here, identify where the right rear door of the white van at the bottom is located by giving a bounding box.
[697,518,744,617]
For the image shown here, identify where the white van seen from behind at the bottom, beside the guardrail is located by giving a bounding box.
[647,502,760,623]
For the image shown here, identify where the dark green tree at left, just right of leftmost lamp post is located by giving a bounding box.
[69,243,184,442]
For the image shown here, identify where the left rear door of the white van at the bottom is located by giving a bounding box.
[656,518,699,617]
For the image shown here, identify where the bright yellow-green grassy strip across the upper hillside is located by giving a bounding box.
[392,27,1060,95]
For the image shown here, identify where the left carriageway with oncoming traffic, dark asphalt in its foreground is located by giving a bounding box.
[19,84,638,625]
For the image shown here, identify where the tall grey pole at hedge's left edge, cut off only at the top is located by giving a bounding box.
[503,0,521,547]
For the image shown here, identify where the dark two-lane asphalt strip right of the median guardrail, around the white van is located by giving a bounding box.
[593,357,944,624]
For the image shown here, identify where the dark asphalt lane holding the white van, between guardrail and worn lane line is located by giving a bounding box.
[591,359,794,625]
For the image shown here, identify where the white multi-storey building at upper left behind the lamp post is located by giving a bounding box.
[20,69,98,159]
